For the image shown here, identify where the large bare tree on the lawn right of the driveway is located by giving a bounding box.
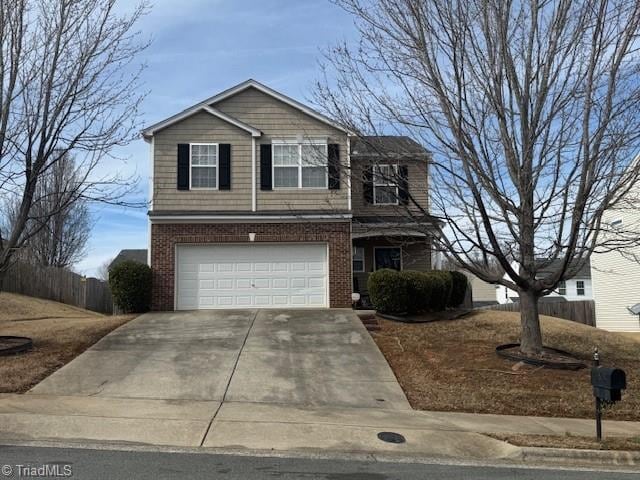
[316,0,640,355]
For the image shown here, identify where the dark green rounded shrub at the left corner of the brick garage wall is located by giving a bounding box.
[109,260,151,313]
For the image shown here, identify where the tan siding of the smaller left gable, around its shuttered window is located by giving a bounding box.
[153,112,251,211]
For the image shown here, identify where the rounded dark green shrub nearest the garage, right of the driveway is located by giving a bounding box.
[367,268,409,313]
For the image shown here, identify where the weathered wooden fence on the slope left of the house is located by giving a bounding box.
[2,262,113,313]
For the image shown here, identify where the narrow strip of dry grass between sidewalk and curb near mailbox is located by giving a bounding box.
[489,434,640,451]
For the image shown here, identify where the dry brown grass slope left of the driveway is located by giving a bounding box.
[0,293,135,393]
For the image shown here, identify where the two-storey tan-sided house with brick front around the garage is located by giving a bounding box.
[143,80,438,310]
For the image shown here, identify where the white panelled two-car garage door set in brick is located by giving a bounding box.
[176,243,327,310]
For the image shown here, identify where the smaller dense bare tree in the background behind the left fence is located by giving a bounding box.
[9,155,91,268]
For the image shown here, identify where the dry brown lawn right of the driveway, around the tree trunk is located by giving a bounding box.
[372,310,640,420]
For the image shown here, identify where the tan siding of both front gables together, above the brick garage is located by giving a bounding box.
[153,88,348,212]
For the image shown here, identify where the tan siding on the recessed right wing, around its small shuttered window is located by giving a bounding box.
[351,158,429,215]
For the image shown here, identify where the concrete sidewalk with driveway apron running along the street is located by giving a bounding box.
[0,394,640,460]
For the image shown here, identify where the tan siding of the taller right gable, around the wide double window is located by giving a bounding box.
[214,88,348,211]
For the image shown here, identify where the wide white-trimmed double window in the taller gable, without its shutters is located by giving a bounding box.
[272,142,329,188]
